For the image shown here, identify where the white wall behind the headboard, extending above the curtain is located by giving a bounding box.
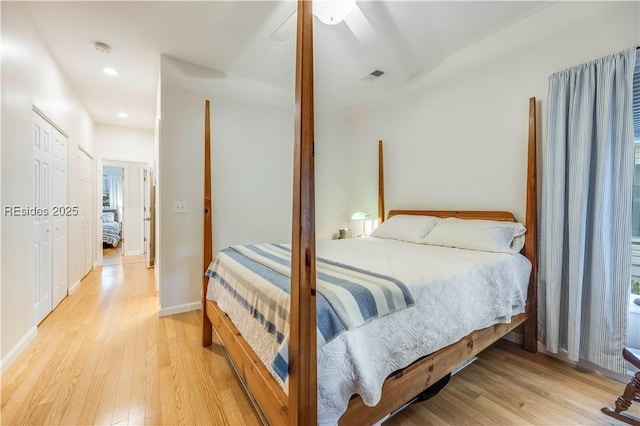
[348,2,640,220]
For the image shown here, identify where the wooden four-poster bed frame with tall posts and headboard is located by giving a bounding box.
[202,0,537,425]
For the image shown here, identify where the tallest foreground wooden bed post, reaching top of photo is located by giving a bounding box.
[289,0,318,426]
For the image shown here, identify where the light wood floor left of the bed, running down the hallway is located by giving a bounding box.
[0,257,260,425]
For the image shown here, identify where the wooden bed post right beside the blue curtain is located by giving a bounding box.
[522,98,538,352]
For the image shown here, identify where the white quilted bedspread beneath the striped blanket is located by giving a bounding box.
[207,237,531,424]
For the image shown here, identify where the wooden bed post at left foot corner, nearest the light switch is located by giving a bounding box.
[202,100,213,346]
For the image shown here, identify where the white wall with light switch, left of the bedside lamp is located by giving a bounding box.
[157,58,347,314]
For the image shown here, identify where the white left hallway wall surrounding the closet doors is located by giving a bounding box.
[0,2,93,370]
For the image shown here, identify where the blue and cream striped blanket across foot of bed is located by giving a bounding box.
[206,244,414,380]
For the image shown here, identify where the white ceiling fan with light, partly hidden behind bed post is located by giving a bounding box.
[271,0,377,44]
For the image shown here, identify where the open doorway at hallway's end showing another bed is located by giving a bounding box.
[102,166,125,264]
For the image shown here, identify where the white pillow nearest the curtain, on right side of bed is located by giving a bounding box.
[422,217,526,253]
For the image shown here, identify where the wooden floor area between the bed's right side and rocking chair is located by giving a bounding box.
[385,340,640,426]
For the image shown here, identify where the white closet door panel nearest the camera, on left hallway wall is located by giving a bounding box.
[32,113,53,324]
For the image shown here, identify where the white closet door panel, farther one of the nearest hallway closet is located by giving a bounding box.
[51,129,69,308]
